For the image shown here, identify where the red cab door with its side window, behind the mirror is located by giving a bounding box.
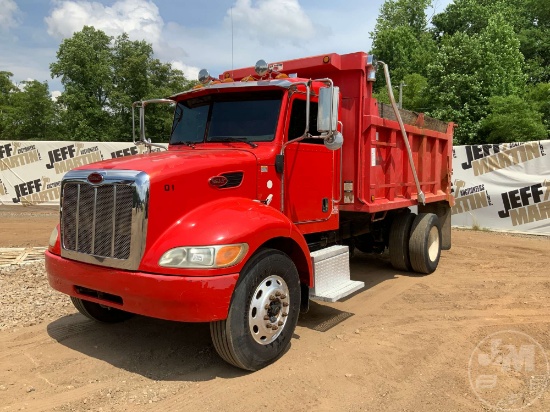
[284,96,340,234]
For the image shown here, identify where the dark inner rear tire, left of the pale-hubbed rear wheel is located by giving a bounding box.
[388,212,416,271]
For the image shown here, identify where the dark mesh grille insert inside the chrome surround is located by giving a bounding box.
[61,182,134,259]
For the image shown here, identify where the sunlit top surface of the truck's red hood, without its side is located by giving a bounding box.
[74,149,256,180]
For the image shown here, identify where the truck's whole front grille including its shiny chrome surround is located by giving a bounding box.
[61,169,150,270]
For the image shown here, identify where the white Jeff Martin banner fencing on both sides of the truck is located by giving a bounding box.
[0,140,550,234]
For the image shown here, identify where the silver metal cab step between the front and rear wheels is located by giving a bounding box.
[309,245,365,302]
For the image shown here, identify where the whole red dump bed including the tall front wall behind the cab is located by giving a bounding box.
[298,52,454,213]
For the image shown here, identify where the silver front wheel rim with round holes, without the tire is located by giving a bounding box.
[248,276,290,345]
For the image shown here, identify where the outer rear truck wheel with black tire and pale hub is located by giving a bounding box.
[409,213,441,274]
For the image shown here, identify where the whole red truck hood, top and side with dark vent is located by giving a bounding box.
[72,149,257,253]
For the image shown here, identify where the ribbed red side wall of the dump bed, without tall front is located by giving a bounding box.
[341,104,453,213]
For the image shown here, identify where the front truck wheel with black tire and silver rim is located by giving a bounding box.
[210,249,301,371]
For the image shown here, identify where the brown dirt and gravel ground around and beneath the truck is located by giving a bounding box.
[0,208,550,412]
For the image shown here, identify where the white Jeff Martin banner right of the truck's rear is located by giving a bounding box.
[451,140,550,235]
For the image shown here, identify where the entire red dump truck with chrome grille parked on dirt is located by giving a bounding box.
[46,52,453,370]
